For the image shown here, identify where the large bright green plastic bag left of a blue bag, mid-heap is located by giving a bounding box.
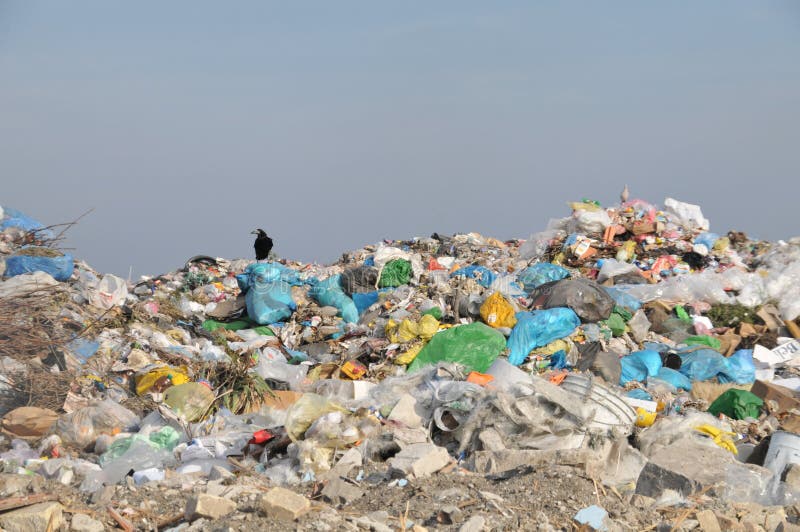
[408,322,506,373]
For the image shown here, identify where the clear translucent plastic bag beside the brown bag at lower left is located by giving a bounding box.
[56,399,139,448]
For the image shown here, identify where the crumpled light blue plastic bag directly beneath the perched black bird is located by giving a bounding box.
[241,262,297,325]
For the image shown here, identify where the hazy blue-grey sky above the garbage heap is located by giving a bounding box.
[0,0,800,277]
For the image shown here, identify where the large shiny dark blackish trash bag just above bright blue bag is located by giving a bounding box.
[531,279,614,323]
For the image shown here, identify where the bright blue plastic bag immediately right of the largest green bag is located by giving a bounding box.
[508,307,581,366]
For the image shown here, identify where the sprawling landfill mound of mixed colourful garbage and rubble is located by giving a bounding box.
[0,198,800,531]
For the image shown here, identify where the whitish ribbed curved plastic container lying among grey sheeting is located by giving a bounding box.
[561,373,636,433]
